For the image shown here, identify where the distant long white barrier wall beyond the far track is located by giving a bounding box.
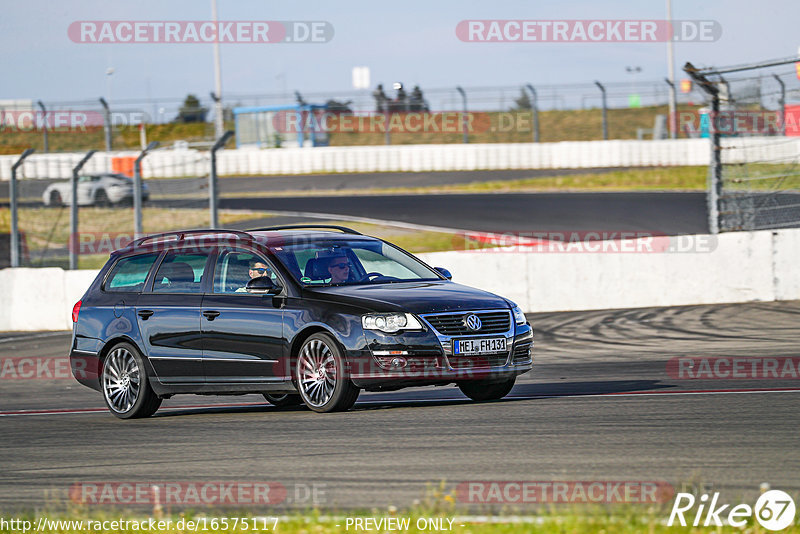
[0,137,800,180]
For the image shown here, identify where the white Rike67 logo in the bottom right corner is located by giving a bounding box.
[667,490,795,531]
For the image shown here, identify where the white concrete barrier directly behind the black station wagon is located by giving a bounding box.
[0,229,800,331]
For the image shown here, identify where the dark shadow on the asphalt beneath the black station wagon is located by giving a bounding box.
[148,380,675,417]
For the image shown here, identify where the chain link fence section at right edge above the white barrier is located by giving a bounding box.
[683,58,800,232]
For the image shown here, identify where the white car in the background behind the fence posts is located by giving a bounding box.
[42,173,150,207]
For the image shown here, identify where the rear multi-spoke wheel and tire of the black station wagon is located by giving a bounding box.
[100,343,161,419]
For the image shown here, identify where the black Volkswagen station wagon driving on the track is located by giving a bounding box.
[70,225,533,418]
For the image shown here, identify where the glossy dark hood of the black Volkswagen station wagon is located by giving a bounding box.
[306,280,509,314]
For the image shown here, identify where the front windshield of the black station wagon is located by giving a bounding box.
[270,239,441,286]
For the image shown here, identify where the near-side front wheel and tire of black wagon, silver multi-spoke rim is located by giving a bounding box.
[295,332,360,413]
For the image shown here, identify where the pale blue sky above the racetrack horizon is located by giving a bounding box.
[0,0,800,105]
